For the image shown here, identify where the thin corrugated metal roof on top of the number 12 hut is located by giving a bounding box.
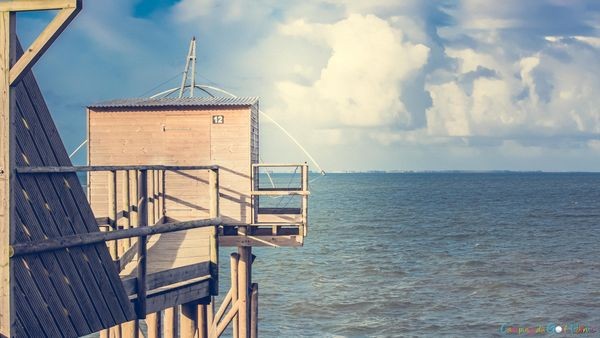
[88,97,258,108]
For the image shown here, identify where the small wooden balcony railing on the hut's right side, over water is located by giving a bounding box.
[251,163,310,237]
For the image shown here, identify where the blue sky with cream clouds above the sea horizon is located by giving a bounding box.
[18,0,600,171]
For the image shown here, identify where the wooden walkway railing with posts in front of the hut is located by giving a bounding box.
[10,165,222,319]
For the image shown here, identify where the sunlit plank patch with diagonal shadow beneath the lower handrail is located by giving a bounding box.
[120,228,210,277]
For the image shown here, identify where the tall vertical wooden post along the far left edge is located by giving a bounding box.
[0,11,16,337]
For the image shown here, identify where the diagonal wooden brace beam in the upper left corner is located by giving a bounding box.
[10,0,81,85]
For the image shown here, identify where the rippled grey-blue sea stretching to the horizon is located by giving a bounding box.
[220,172,600,337]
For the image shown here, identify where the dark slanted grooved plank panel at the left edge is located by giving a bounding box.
[13,44,135,337]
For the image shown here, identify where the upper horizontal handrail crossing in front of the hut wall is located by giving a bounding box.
[15,165,219,174]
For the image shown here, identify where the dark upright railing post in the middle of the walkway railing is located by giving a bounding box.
[136,170,148,319]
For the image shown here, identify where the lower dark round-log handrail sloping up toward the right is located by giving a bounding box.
[10,217,223,257]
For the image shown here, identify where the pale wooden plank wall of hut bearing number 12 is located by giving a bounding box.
[88,107,252,224]
